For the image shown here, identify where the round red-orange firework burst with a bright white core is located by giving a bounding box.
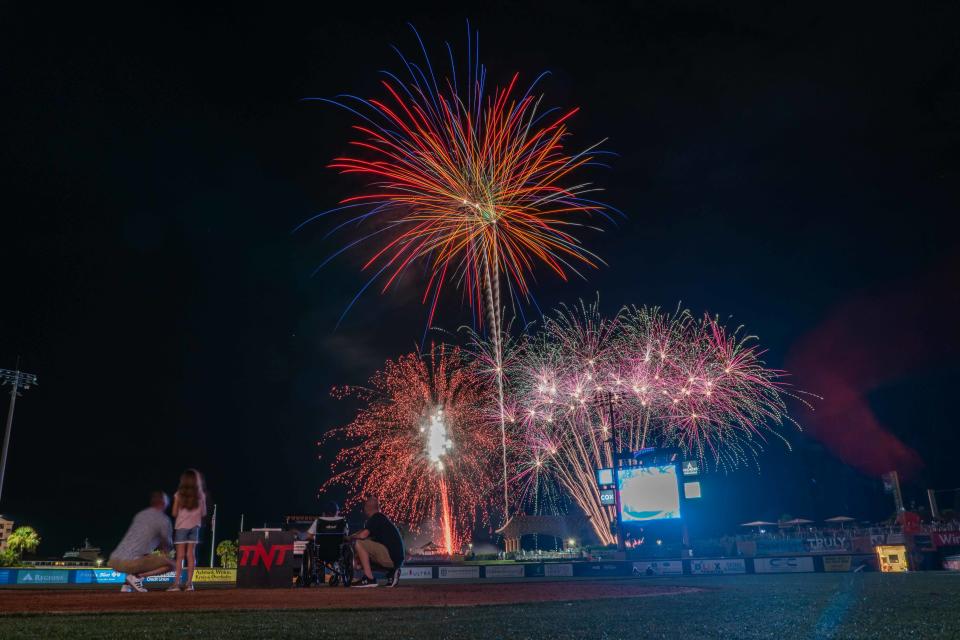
[324,346,500,553]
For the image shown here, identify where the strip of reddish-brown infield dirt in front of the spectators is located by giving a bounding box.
[0,580,700,614]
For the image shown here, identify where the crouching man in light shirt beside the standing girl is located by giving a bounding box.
[107,491,174,592]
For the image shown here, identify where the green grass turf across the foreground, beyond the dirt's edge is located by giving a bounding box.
[0,573,960,640]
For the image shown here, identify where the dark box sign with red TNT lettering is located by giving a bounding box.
[237,531,300,589]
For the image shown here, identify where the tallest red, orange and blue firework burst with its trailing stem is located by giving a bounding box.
[304,26,624,516]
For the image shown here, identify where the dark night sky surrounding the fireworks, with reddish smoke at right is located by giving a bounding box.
[0,2,960,557]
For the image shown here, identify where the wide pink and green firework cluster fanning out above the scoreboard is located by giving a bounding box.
[507,304,808,542]
